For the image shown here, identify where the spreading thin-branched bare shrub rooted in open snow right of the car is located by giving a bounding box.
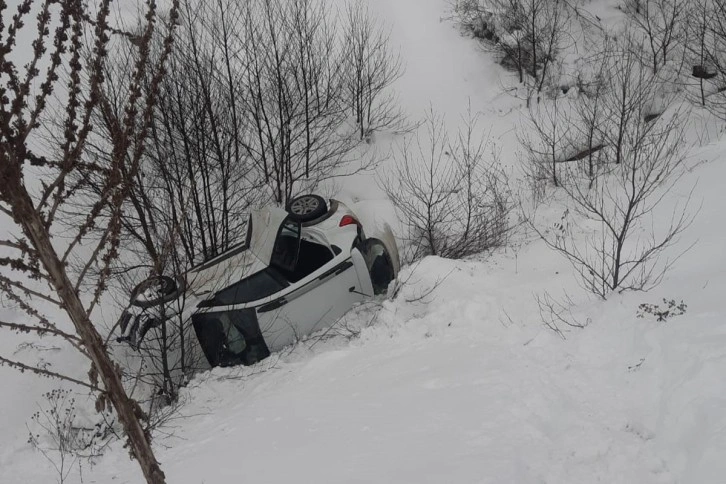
[540,111,692,298]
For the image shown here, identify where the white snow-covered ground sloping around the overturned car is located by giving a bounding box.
[0,0,726,484]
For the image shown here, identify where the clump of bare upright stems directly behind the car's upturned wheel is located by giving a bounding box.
[240,0,362,203]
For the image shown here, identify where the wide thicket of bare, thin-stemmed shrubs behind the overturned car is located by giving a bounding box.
[124,0,405,216]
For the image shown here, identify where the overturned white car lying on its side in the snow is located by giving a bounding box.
[118,195,399,366]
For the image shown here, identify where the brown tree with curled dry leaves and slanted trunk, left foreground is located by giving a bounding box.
[0,0,178,484]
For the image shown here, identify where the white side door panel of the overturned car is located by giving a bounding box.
[257,256,369,351]
